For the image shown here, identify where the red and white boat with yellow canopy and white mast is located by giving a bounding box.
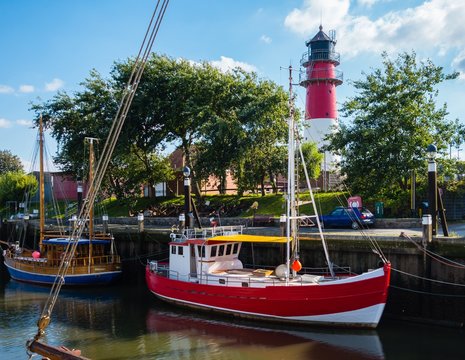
[146,68,391,328]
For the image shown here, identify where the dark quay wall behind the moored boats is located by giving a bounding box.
[0,218,465,327]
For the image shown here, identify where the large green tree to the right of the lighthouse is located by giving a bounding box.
[329,52,458,198]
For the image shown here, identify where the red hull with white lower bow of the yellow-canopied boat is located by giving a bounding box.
[146,264,390,327]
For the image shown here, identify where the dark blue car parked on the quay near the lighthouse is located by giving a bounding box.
[320,206,375,230]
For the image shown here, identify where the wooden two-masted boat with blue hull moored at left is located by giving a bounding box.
[4,121,122,286]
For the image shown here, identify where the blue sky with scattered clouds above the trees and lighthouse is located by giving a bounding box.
[0,0,465,170]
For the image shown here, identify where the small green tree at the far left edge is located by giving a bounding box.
[0,171,39,204]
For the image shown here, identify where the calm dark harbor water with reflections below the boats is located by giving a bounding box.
[0,270,465,360]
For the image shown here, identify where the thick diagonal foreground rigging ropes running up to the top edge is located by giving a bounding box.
[29,0,169,346]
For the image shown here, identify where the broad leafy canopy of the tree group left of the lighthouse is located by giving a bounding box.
[32,54,287,196]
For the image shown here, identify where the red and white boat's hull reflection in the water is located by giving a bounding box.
[147,308,384,359]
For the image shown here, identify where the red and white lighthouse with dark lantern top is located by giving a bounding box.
[299,25,342,190]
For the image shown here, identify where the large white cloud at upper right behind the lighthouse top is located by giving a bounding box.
[284,0,465,65]
